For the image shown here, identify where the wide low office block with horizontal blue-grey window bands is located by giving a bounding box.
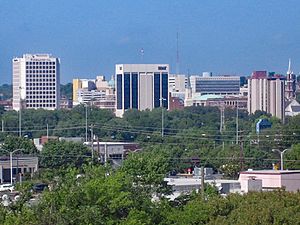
[190,72,240,95]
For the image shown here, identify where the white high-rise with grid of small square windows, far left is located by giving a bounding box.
[12,54,60,110]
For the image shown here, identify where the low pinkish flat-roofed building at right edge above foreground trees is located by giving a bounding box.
[239,170,300,193]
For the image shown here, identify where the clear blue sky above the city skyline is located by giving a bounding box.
[0,0,300,84]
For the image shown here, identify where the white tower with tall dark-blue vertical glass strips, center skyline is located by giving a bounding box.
[116,64,169,117]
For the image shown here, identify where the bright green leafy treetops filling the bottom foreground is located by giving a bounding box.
[0,163,300,225]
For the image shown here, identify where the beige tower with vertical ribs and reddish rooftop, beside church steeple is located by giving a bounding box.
[248,71,285,121]
